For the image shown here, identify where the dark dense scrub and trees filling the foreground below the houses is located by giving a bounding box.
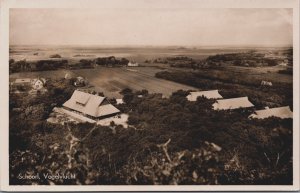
[10,81,292,184]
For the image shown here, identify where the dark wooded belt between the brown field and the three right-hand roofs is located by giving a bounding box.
[155,70,293,109]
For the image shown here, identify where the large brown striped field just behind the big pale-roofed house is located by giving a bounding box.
[72,67,196,98]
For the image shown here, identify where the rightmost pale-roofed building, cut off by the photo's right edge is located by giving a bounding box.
[249,106,293,119]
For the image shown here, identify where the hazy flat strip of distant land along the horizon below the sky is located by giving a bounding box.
[10,45,276,62]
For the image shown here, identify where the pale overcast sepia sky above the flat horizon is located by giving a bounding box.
[10,4,293,46]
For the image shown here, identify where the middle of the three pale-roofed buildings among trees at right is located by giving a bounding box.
[213,97,254,110]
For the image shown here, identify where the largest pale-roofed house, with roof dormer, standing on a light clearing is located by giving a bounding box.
[63,90,120,119]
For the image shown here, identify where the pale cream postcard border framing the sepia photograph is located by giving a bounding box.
[0,0,300,191]
